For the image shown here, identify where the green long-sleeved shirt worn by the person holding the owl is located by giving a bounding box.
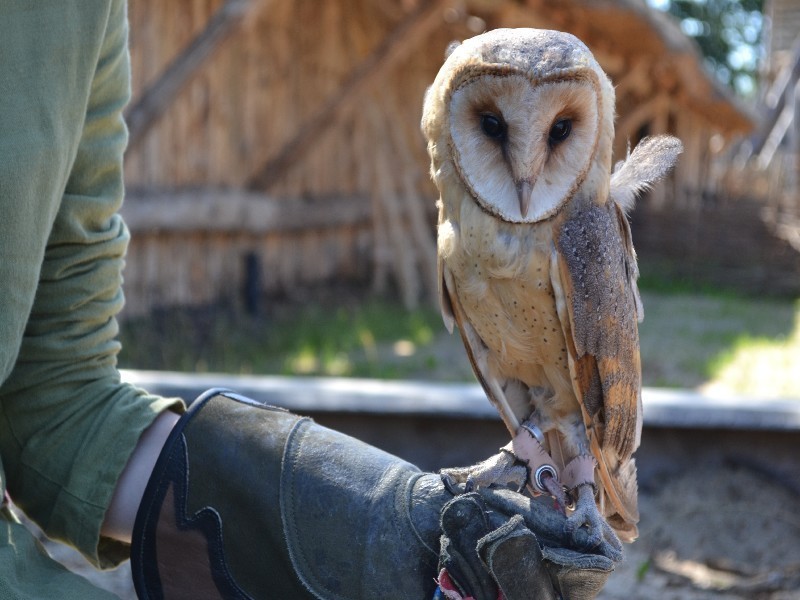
[0,0,180,598]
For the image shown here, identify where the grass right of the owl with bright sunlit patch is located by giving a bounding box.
[639,292,800,397]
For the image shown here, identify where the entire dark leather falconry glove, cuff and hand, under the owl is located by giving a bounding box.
[131,390,613,600]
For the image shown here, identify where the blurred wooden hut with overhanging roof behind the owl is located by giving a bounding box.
[123,0,751,314]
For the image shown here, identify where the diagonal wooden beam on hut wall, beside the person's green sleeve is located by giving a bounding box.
[126,0,259,151]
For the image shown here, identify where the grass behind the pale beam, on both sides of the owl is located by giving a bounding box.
[120,285,800,397]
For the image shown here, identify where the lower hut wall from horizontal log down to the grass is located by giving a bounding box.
[121,189,372,317]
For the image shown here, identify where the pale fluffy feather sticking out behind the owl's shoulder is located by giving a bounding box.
[611,135,683,213]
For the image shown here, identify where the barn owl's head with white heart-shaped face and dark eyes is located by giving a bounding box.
[422,29,614,223]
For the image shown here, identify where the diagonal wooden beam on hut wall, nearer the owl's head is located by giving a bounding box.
[249,0,443,190]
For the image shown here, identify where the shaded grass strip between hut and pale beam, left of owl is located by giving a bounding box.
[120,298,441,378]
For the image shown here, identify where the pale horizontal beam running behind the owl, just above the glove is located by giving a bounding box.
[120,370,800,432]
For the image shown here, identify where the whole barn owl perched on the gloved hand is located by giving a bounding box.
[422,29,682,557]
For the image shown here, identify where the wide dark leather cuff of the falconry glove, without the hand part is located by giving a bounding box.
[131,390,449,600]
